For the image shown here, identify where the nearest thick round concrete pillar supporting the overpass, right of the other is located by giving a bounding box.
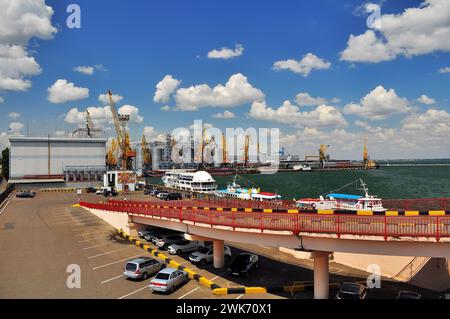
[311,251,330,299]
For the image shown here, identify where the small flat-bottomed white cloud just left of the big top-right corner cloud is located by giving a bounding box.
[273,52,331,77]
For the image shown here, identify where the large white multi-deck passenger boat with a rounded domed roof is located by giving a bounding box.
[162,170,217,194]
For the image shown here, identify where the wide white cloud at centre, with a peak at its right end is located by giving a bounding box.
[175,73,264,111]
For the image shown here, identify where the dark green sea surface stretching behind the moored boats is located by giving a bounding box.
[150,166,450,199]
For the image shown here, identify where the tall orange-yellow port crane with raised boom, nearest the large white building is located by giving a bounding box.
[108,90,136,170]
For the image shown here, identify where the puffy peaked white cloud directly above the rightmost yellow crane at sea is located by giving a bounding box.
[344,85,410,120]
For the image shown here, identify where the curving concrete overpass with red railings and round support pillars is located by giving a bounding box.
[80,201,450,299]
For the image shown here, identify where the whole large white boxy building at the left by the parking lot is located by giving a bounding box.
[9,137,106,184]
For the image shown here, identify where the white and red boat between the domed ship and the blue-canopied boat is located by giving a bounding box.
[216,174,281,201]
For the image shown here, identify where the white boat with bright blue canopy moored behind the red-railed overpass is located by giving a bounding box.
[296,179,387,212]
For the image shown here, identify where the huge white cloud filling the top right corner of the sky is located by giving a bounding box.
[340,0,450,63]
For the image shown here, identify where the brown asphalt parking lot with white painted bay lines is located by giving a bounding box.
[0,192,435,299]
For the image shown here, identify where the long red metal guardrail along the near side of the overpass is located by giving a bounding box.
[80,201,450,241]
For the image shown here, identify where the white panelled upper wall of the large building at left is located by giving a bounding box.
[10,137,106,179]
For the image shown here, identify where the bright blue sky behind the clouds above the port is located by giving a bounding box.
[0,0,450,158]
